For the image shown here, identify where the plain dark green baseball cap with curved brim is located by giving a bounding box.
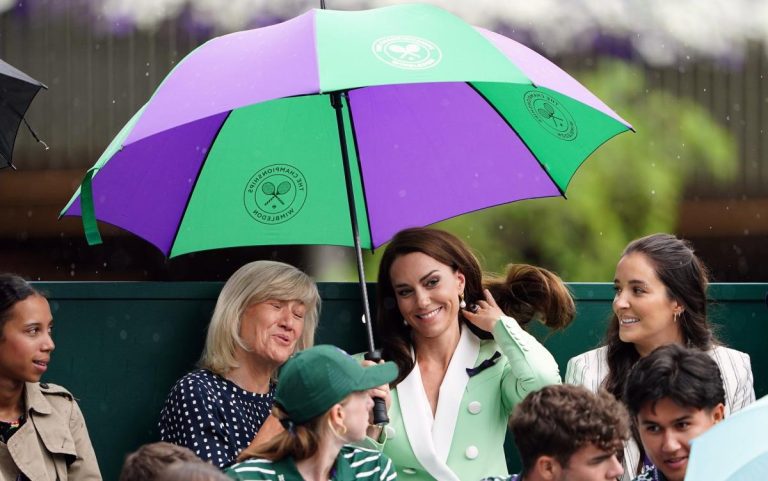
[275,345,397,424]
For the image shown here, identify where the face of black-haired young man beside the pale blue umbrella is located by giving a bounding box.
[637,398,725,481]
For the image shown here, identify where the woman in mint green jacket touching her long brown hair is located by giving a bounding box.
[369,228,575,481]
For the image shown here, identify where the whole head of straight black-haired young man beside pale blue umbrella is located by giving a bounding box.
[624,344,725,481]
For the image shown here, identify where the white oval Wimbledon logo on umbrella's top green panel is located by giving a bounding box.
[371,35,443,70]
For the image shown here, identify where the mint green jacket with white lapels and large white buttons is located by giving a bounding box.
[370,317,560,481]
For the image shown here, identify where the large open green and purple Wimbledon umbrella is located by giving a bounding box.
[62,1,632,342]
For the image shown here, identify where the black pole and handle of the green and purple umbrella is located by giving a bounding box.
[331,92,389,425]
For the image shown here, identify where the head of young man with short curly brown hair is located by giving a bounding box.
[510,385,629,481]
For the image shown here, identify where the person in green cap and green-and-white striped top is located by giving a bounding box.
[225,345,397,481]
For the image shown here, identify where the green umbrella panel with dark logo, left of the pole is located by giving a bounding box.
[171,96,371,256]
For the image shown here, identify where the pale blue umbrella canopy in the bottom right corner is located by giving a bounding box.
[685,396,768,481]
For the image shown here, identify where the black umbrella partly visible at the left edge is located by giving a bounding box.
[0,60,48,169]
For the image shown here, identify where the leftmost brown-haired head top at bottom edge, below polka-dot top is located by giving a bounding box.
[119,442,204,481]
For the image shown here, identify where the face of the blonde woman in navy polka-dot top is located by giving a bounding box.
[240,299,306,367]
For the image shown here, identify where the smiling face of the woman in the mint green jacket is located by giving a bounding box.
[389,252,464,339]
